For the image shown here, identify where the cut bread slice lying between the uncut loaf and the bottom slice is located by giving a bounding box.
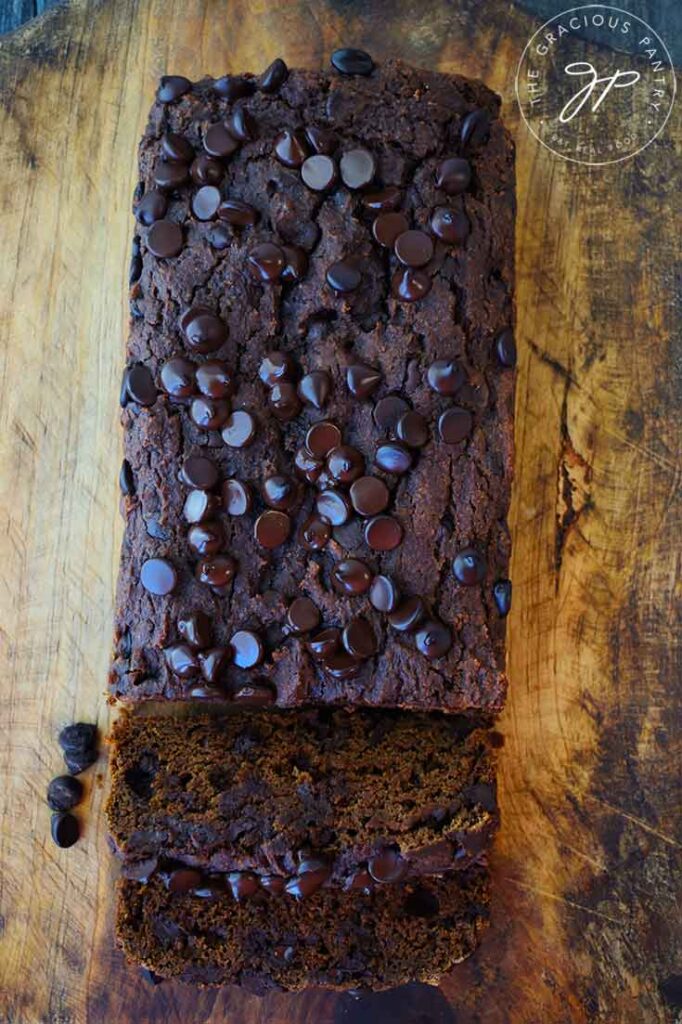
[106,711,498,884]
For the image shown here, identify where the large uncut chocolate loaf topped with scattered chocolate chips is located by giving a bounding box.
[111,61,514,712]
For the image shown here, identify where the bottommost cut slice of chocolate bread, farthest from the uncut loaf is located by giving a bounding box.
[116,870,488,993]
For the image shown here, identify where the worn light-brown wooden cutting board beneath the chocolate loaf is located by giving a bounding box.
[0,0,681,1024]
